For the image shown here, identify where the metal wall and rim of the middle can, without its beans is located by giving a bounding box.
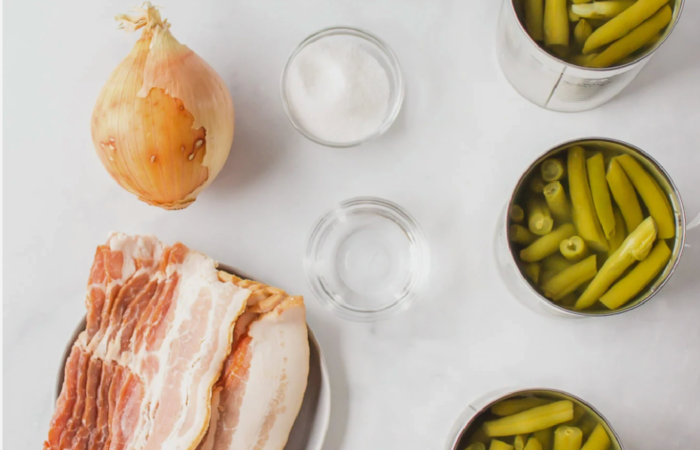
[494,137,686,319]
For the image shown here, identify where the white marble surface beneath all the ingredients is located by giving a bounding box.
[3,0,700,450]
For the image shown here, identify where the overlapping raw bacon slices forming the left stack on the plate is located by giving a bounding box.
[44,234,250,450]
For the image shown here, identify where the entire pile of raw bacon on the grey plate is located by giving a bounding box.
[44,234,309,450]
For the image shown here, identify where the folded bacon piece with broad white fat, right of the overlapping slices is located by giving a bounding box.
[198,292,309,450]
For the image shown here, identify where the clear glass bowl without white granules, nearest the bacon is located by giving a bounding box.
[304,197,430,322]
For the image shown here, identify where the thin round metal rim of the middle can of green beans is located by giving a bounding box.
[503,136,686,318]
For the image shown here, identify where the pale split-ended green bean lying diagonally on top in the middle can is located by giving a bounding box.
[575,217,657,310]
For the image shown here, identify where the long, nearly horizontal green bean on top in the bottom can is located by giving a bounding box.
[483,400,574,437]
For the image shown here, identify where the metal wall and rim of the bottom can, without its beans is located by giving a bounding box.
[445,388,624,450]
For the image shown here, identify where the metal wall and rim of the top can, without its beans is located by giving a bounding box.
[496,0,684,112]
